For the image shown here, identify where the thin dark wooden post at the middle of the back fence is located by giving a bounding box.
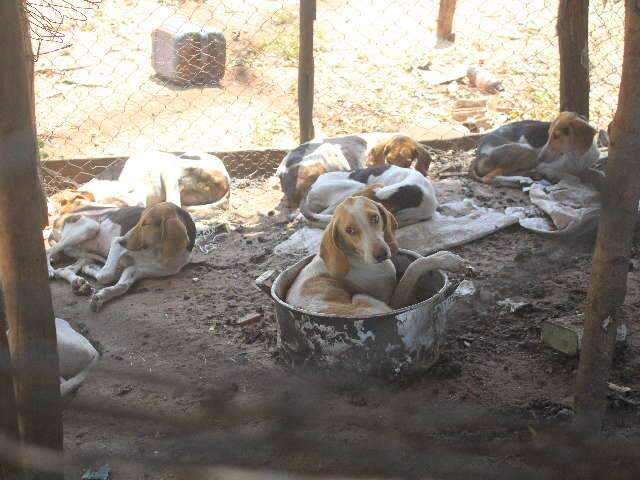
[298,0,316,143]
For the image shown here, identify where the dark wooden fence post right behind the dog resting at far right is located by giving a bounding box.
[556,0,590,118]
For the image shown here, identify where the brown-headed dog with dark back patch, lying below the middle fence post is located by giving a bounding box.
[276,133,430,207]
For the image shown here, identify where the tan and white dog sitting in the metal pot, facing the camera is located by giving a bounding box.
[286,197,468,316]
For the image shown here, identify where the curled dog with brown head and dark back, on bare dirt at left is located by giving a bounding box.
[47,202,196,311]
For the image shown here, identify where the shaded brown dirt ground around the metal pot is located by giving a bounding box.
[52,148,640,480]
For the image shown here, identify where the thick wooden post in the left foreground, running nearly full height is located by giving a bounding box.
[0,0,62,479]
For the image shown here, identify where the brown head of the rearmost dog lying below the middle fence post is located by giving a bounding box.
[367,135,431,177]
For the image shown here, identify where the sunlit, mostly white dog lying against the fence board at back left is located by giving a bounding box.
[50,151,231,214]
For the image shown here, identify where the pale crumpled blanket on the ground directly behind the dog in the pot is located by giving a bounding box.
[274,199,519,255]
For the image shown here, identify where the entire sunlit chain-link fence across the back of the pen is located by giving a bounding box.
[36,0,623,190]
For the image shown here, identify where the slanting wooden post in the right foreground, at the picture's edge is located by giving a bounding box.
[575,0,640,433]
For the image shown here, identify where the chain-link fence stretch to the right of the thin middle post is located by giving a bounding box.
[315,0,624,138]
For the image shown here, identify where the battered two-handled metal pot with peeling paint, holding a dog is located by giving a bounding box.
[271,250,473,376]
